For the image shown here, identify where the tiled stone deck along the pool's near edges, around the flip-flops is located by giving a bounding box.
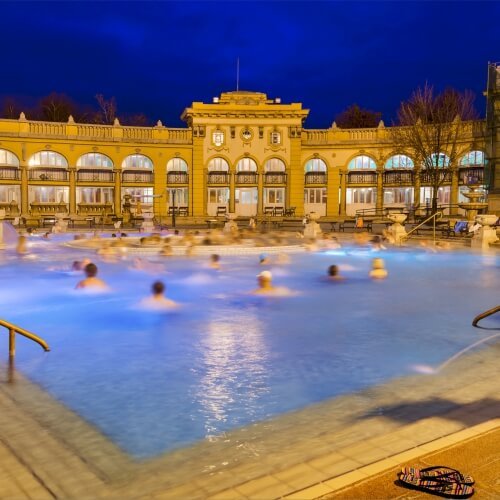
[0,338,500,500]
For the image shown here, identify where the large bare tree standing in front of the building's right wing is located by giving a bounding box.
[391,84,477,213]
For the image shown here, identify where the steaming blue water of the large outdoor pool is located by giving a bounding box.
[0,236,499,459]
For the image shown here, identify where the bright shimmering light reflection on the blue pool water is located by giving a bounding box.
[195,310,269,438]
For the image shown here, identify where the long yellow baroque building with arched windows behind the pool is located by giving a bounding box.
[0,65,500,225]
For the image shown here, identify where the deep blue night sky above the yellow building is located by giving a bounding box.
[0,1,500,128]
